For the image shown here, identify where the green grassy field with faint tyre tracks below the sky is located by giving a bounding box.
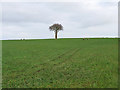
[2,38,118,88]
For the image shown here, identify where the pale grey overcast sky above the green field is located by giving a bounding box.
[0,0,118,40]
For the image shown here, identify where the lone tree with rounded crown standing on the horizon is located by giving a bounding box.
[49,24,63,39]
